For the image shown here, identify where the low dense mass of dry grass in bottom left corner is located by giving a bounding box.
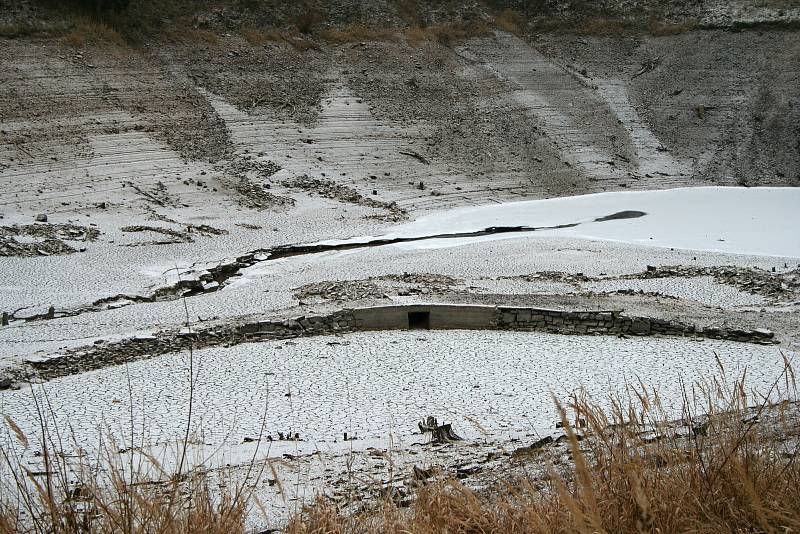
[0,406,248,534]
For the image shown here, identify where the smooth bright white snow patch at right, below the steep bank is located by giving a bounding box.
[328,187,800,258]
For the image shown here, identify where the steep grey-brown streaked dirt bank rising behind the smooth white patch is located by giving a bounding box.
[0,26,800,224]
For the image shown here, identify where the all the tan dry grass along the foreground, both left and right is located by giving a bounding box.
[0,346,800,534]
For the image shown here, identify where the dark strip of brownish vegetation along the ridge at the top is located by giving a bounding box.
[6,0,797,45]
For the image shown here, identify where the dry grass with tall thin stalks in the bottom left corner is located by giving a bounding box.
[0,300,258,534]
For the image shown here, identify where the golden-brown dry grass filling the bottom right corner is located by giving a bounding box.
[287,362,800,534]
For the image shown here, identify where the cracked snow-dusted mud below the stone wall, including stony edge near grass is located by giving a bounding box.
[0,331,795,528]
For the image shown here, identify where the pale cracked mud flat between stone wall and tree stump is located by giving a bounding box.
[0,331,783,460]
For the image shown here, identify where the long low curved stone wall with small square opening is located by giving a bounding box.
[20,304,778,390]
